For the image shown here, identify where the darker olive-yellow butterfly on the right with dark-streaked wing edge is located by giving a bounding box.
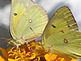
[42,6,81,58]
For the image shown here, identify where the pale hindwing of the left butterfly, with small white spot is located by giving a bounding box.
[16,5,48,39]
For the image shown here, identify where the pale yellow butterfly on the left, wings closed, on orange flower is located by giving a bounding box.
[10,0,48,45]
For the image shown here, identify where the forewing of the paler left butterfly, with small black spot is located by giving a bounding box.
[10,0,35,39]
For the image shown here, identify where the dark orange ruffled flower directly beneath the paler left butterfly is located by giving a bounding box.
[8,42,40,61]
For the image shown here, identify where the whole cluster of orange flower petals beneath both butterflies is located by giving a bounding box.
[0,41,77,61]
